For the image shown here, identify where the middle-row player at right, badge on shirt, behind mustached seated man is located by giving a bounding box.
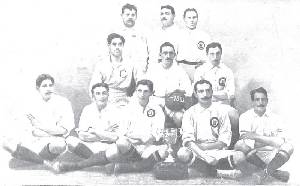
[194,43,239,148]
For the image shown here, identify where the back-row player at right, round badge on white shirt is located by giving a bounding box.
[177,8,211,82]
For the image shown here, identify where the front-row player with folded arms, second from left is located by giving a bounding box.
[54,83,119,172]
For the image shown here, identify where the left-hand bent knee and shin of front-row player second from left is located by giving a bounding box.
[66,136,93,159]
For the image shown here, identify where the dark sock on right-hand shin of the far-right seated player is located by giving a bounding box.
[267,150,290,175]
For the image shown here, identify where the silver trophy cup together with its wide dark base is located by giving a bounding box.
[153,128,188,180]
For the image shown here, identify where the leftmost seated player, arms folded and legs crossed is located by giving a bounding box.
[3,74,74,167]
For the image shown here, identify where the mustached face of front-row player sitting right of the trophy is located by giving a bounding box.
[195,83,213,105]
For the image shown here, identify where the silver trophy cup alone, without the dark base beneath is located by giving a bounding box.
[164,128,178,162]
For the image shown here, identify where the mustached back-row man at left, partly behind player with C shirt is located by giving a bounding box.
[113,4,148,79]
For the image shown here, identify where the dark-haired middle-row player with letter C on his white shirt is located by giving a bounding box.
[90,33,136,106]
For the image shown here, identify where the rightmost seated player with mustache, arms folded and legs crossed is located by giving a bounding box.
[235,87,293,183]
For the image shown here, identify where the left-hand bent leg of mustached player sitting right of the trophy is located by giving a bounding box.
[177,147,217,177]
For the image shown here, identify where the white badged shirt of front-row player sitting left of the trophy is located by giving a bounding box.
[122,98,165,143]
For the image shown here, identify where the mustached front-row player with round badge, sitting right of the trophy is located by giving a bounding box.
[177,80,245,177]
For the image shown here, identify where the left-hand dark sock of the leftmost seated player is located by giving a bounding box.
[11,145,44,164]
